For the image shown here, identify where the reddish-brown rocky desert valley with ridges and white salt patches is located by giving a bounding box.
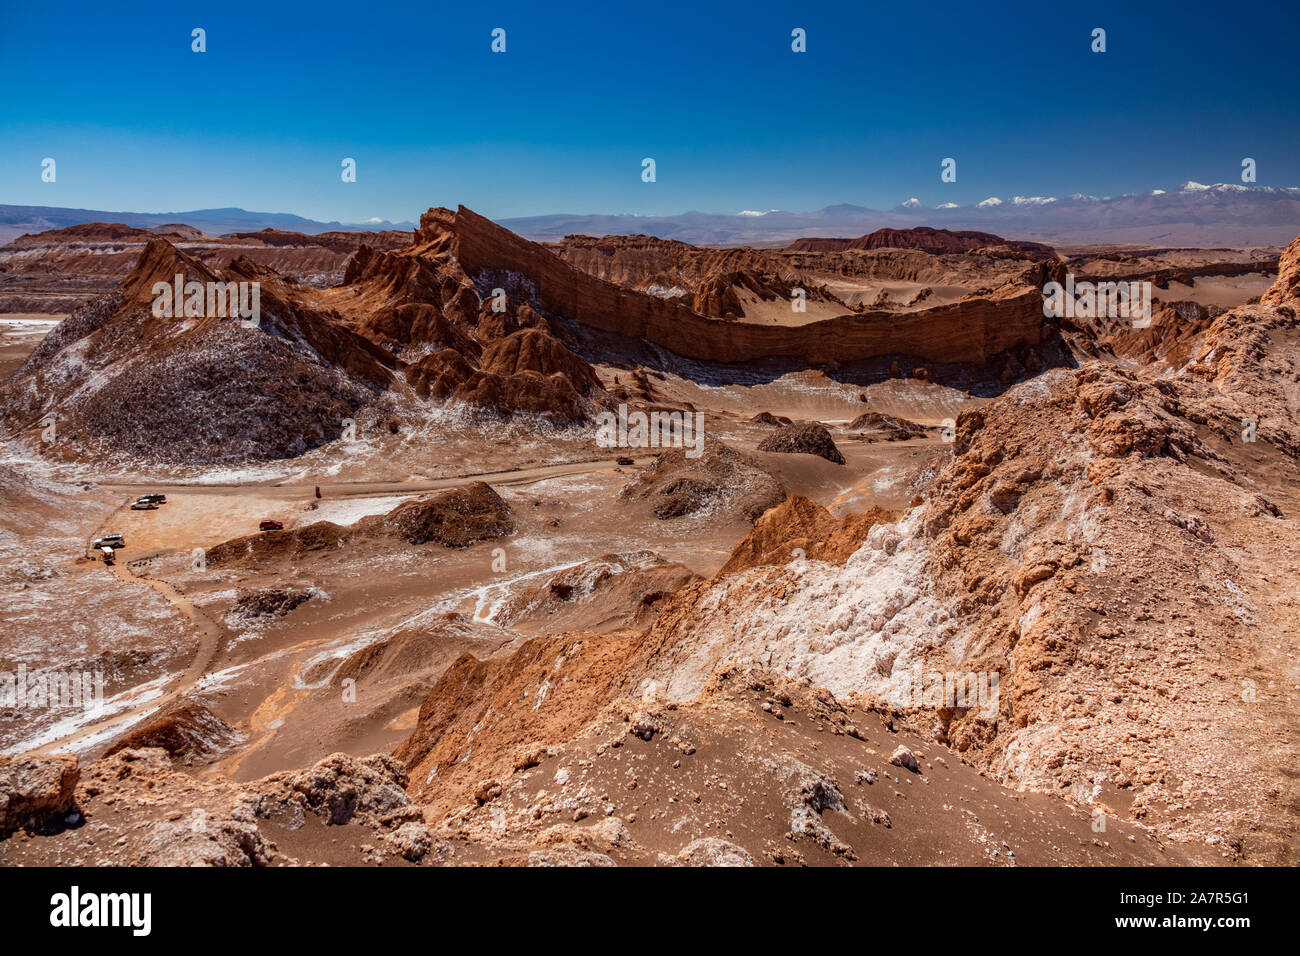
[0,207,1300,866]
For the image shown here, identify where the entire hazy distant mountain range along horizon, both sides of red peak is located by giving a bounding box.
[0,182,1300,247]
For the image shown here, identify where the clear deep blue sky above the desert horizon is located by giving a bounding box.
[0,0,1300,222]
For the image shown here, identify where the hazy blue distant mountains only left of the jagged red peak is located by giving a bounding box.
[0,206,415,243]
